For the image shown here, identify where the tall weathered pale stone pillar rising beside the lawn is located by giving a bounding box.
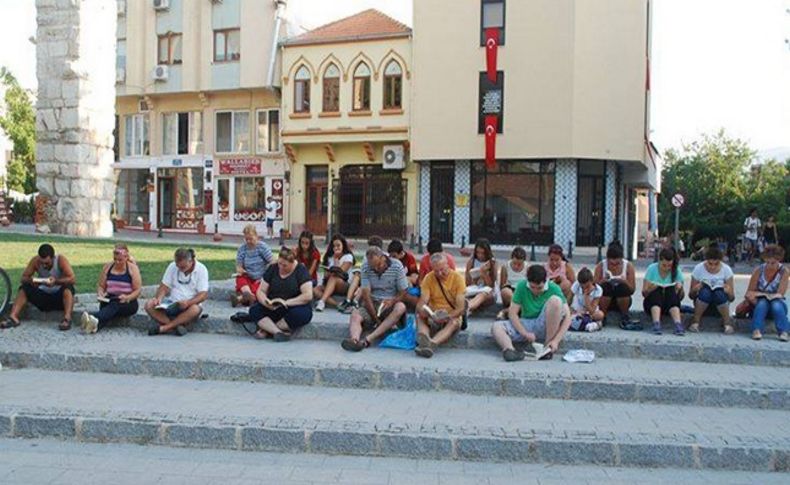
[36,0,118,237]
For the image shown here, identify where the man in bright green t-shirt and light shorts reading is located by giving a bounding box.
[491,264,571,362]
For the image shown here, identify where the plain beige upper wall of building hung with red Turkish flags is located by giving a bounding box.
[411,0,648,161]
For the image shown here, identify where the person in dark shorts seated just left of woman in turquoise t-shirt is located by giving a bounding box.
[593,241,640,330]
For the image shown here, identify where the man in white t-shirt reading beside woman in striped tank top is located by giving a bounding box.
[145,248,208,337]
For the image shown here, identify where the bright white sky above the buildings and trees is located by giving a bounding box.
[0,0,790,156]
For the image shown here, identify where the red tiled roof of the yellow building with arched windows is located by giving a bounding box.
[284,8,411,46]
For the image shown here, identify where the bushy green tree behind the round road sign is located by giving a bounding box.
[659,130,756,233]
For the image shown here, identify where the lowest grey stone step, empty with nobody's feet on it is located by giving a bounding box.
[0,369,790,472]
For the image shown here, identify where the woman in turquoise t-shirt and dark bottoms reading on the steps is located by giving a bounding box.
[642,247,685,335]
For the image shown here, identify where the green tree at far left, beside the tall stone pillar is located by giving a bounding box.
[0,67,36,194]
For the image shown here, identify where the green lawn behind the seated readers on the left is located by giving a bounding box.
[0,233,241,293]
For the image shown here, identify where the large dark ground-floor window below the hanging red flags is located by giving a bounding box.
[471,161,554,244]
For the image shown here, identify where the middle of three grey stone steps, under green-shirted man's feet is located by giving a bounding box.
[0,325,790,410]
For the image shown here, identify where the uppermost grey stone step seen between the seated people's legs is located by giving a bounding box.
[15,300,790,367]
